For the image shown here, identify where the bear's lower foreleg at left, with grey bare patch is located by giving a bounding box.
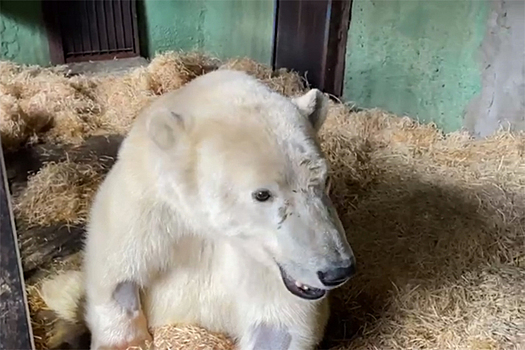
[86,282,152,350]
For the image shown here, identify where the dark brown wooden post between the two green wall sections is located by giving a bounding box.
[272,0,352,97]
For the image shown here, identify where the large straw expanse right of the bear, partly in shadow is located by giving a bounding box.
[322,106,525,350]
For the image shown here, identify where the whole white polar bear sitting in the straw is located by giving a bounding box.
[39,70,355,350]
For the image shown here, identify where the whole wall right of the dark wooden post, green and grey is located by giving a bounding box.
[344,0,525,136]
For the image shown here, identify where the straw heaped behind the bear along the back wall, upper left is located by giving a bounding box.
[0,52,304,151]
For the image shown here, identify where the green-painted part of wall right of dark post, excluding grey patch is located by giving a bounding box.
[344,0,490,131]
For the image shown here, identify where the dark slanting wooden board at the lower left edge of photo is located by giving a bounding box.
[0,143,35,350]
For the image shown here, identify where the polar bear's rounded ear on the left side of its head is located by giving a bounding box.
[147,109,185,149]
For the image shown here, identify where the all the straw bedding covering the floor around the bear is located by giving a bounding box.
[0,53,525,350]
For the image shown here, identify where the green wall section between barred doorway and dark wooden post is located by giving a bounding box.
[139,0,274,64]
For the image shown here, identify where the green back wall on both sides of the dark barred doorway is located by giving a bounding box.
[0,0,274,66]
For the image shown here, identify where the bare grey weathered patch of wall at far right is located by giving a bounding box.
[465,0,525,137]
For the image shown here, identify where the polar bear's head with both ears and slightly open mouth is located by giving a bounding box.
[146,70,355,300]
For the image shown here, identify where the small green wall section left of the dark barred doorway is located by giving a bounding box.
[0,0,50,66]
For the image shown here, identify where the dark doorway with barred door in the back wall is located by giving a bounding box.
[42,0,140,64]
